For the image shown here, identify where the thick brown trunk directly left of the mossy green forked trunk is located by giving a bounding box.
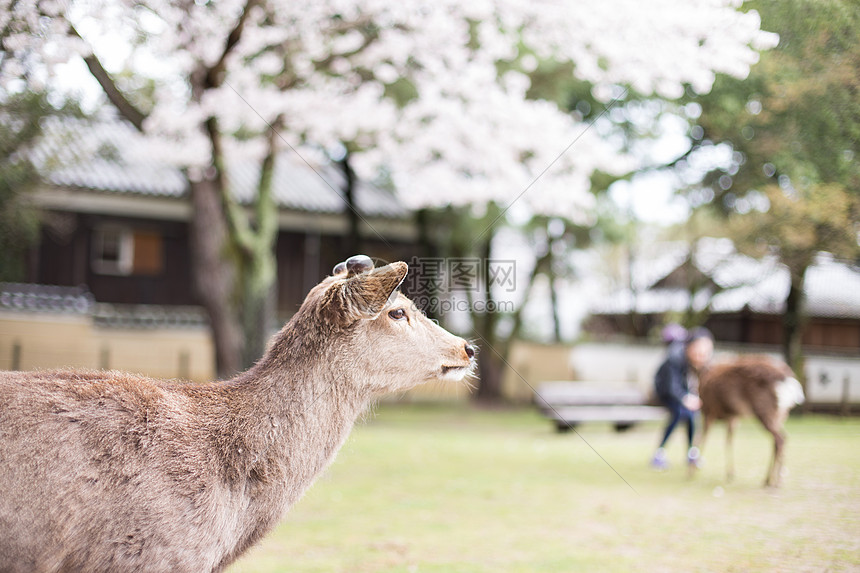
[189,179,242,378]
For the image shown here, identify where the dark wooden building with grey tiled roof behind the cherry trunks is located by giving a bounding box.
[26,117,415,321]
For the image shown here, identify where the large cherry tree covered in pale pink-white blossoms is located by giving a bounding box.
[0,0,774,384]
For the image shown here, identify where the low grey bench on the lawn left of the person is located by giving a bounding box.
[534,382,666,432]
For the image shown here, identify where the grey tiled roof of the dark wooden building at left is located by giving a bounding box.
[33,118,407,218]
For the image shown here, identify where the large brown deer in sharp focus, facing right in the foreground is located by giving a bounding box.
[0,256,474,572]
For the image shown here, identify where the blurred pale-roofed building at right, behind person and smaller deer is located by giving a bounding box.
[586,239,860,352]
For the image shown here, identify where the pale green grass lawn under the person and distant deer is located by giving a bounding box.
[230,405,860,573]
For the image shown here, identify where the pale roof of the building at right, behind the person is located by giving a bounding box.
[591,239,860,319]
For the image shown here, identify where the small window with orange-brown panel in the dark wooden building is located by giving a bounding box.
[92,225,164,275]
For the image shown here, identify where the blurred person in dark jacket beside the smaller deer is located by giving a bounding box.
[651,325,714,470]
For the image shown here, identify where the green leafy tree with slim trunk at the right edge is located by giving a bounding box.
[679,0,860,380]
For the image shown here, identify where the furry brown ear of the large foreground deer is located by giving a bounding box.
[327,262,409,323]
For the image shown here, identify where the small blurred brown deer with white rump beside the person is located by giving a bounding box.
[699,356,803,487]
